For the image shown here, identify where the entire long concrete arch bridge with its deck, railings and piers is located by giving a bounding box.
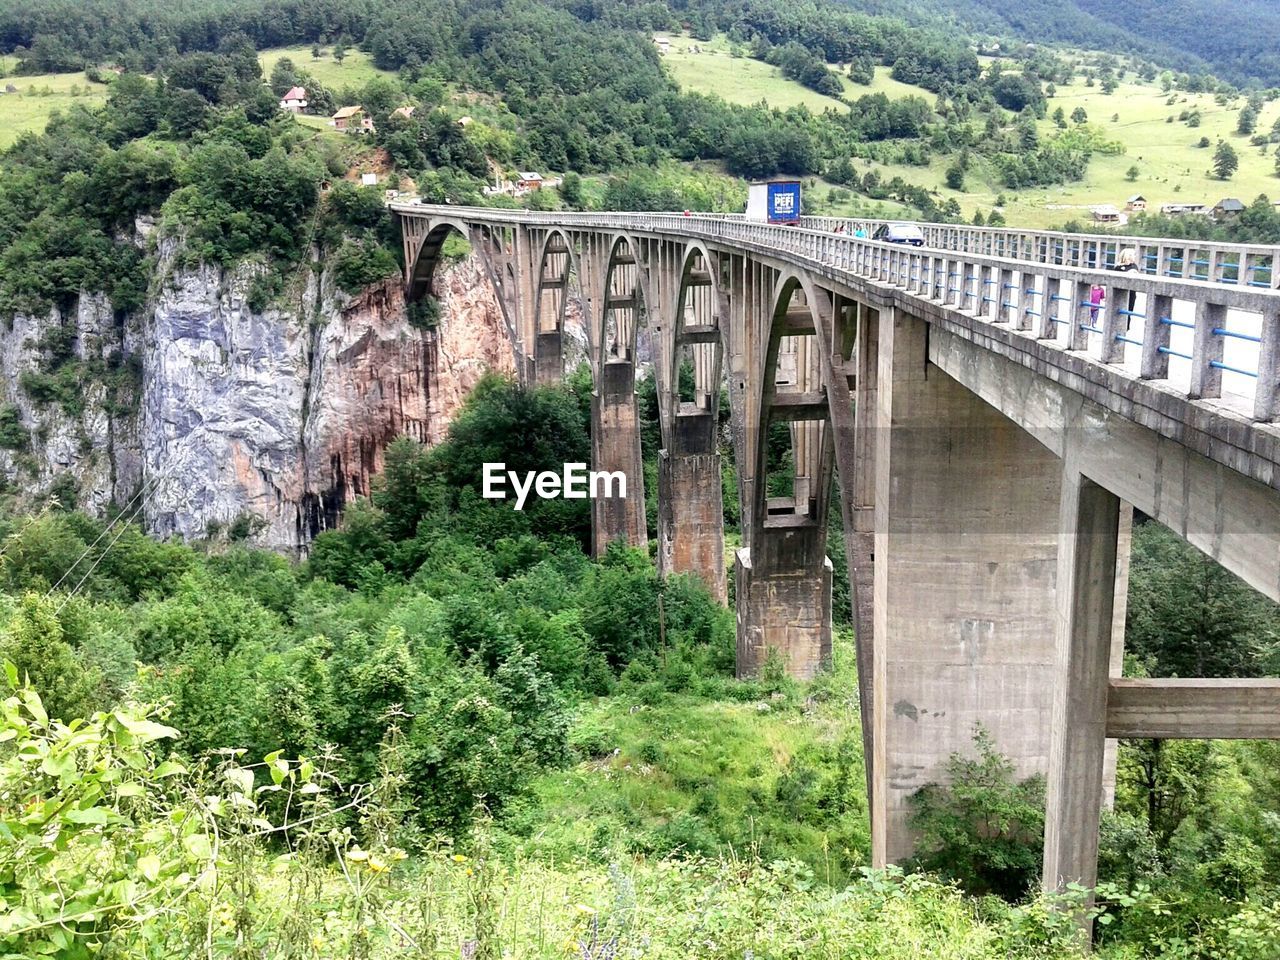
[392,204,1280,916]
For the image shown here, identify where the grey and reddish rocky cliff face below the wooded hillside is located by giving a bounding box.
[0,244,515,550]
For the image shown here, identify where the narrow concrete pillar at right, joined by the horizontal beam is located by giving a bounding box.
[1043,473,1121,911]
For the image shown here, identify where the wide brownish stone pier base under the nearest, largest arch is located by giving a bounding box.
[733,529,832,680]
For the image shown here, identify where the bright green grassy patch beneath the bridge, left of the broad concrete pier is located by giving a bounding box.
[508,635,869,883]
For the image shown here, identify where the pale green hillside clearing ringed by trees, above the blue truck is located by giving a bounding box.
[655,33,932,113]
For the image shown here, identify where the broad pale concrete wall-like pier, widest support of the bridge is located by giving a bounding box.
[872,311,1061,865]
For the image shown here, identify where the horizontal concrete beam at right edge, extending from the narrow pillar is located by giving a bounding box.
[1106,678,1280,740]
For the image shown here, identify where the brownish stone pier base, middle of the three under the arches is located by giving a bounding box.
[658,413,728,603]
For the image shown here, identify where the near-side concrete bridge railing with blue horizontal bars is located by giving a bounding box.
[393,205,1280,422]
